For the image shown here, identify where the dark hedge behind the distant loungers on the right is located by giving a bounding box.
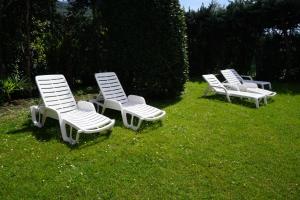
[186,0,300,80]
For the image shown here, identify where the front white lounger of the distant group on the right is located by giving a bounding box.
[202,74,267,108]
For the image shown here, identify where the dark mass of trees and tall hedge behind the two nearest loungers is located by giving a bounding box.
[0,0,188,100]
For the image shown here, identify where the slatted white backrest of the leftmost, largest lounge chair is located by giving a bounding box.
[35,74,77,113]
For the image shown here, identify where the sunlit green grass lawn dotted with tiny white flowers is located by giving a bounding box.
[0,81,300,199]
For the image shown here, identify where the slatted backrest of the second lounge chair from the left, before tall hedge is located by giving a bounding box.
[95,72,128,104]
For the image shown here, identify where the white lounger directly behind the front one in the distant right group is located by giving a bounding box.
[221,69,276,97]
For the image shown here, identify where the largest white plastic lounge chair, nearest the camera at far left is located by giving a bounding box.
[30,75,115,144]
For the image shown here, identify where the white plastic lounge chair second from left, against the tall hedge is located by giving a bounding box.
[90,72,166,130]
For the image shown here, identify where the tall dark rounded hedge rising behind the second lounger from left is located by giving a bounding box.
[101,0,188,98]
